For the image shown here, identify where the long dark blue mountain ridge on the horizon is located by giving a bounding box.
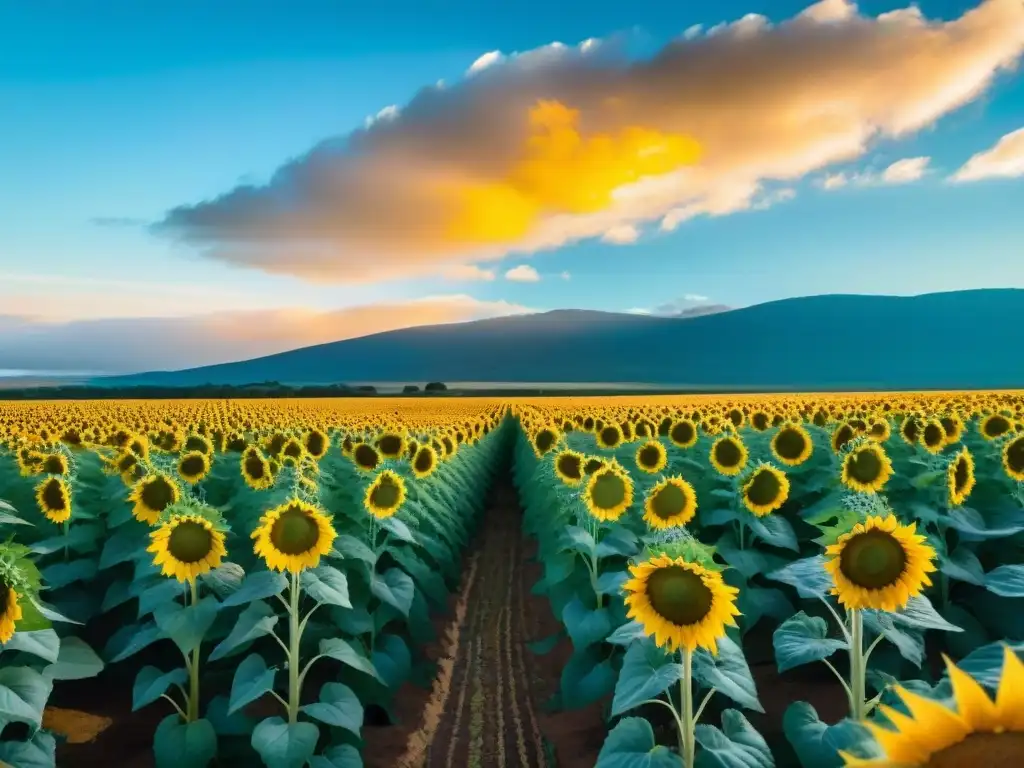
[94,289,1024,390]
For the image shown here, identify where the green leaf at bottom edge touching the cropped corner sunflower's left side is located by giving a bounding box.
[782,701,883,768]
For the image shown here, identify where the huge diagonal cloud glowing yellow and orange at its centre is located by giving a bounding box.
[155,0,1024,283]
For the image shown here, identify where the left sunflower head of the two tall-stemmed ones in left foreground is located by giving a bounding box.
[146,513,227,582]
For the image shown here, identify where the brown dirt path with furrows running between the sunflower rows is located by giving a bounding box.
[364,477,607,768]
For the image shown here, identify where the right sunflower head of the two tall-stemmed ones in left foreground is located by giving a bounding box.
[252,499,337,573]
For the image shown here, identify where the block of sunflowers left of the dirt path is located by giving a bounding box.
[0,399,509,768]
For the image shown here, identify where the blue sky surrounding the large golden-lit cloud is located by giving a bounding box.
[0,0,1024,369]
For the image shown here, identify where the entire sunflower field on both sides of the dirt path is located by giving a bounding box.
[0,392,1024,768]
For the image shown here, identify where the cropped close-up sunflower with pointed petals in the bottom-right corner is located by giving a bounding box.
[840,645,1024,768]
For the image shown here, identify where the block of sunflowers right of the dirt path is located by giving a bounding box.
[512,392,1024,768]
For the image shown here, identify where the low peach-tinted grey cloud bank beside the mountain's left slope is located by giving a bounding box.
[0,295,531,373]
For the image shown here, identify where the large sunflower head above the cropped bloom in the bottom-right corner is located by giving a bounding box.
[825,515,935,611]
